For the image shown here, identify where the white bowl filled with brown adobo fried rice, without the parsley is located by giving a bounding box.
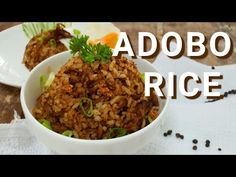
[21,51,168,154]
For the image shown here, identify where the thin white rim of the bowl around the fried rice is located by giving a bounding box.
[20,51,169,144]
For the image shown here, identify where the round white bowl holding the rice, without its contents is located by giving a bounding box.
[21,51,168,154]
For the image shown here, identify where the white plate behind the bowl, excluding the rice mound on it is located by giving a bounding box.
[0,23,119,87]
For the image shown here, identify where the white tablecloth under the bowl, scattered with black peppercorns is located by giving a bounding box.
[0,46,236,154]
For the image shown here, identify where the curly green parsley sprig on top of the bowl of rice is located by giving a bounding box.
[70,35,112,64]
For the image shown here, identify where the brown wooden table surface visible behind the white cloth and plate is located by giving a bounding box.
[0,22,236,123]
